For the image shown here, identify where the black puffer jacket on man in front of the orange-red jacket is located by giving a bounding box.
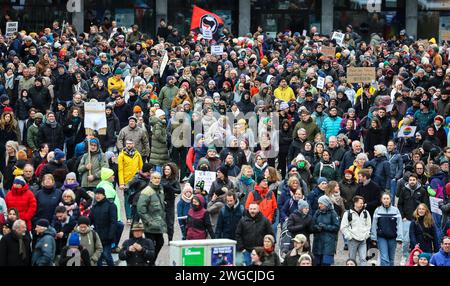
[236,211,273,251]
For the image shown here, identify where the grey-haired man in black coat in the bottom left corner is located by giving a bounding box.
[0,219,31,267]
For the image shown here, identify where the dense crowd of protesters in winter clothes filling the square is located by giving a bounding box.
[0,5,450,266]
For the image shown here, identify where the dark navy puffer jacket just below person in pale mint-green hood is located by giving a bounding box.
[89,198,117,244]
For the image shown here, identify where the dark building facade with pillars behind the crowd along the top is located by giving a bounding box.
[0,0,450,39]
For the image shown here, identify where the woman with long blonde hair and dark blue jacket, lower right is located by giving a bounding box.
[409,203,439,253]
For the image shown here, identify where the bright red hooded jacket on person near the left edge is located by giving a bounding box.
[5,184,37,231]
